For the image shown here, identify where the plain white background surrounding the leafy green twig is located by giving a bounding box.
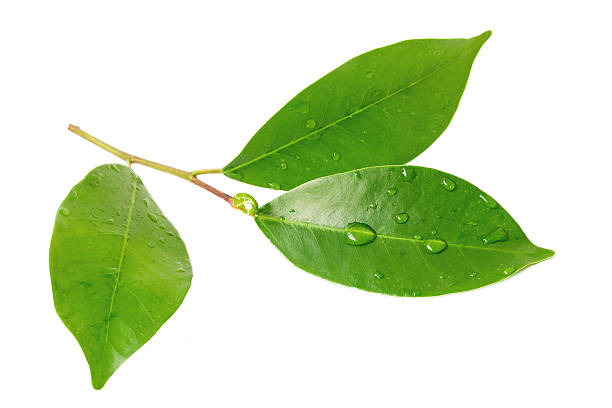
[0,0,612,407]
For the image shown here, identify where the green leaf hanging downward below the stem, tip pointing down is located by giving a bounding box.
[49,164,192,389]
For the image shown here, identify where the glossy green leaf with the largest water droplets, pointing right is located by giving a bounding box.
[255,166,553,296]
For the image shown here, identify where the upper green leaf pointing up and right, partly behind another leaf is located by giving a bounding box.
[223,31,491,190]
